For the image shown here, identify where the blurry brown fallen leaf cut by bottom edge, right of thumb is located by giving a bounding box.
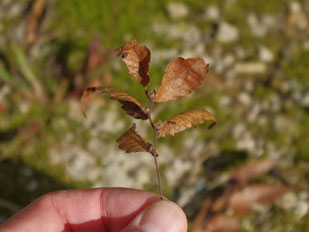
[206,213,240,232]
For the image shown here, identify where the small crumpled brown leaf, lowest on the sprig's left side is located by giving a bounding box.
[117,124,152,153]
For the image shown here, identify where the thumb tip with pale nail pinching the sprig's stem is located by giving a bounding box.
[124,200,187,232]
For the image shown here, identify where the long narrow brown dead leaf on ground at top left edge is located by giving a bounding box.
[26,0,46,45]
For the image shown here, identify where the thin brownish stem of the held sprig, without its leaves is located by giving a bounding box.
[145,88,163,200]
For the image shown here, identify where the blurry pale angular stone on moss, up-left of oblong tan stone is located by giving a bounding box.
[217,22,239,43]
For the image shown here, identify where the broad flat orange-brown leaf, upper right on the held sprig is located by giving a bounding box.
[155,57,209,102]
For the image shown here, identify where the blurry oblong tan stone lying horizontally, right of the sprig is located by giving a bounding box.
[234,62,267,75]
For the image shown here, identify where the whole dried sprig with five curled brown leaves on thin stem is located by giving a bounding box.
[81,40,216,199]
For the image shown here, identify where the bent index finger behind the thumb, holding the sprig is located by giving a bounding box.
[0,188,159,232]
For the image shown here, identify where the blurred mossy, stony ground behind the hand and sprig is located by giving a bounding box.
[0,0,309,232]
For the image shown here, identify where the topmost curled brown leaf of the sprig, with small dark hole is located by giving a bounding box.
[116,40,151,86]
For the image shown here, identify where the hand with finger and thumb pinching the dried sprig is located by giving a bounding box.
[0,188,187,232]
